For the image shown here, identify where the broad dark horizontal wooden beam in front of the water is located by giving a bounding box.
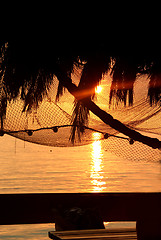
[0,193,161,225]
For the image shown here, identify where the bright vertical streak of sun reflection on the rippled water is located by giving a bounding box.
[90,133,106,192]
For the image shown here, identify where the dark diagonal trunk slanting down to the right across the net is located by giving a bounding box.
[57,72,161,148]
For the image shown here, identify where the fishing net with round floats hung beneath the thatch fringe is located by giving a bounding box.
[0,76,161,160]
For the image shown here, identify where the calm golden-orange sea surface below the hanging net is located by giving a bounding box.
[0,135,161,240]
